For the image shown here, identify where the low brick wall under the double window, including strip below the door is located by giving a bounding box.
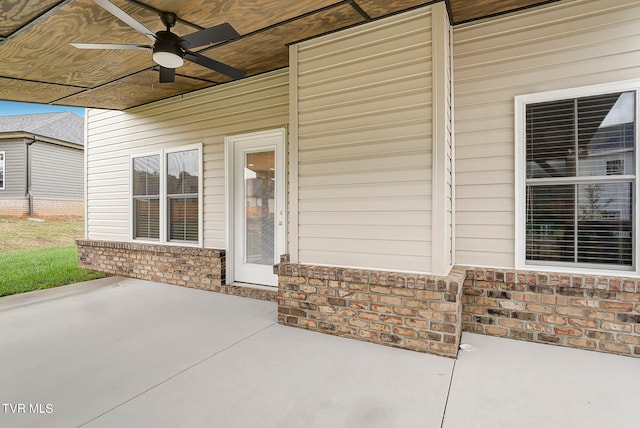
[76,240,276,301]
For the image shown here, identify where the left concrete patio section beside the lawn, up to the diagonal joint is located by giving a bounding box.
[0,278,276,427]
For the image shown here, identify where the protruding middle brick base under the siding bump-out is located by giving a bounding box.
[274,257,464,357]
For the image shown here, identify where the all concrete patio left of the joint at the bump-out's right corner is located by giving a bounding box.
[0,279,454,427]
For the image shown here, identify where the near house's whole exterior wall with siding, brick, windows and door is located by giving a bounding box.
[72,0,640,357]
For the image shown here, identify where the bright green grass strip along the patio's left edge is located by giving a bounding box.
[0,246,105,297]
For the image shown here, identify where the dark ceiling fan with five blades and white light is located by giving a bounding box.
[69,0,245,83]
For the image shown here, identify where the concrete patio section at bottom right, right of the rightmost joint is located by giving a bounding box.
[443,333,640,428]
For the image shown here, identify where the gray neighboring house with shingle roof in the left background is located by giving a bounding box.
[0,113,84,217]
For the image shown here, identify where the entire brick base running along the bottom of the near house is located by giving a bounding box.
[77,240,640,357]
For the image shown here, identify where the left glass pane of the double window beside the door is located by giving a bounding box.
[133,155,160,240]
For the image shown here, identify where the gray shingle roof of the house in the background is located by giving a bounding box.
[0,112,84,145]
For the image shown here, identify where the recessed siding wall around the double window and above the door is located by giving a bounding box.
[87,70,288,244]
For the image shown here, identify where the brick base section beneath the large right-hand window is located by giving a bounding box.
[462,268,640,357]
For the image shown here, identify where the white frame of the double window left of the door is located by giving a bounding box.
[129,143,204,247]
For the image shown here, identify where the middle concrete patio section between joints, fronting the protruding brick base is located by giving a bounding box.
[87,325,453,428]
